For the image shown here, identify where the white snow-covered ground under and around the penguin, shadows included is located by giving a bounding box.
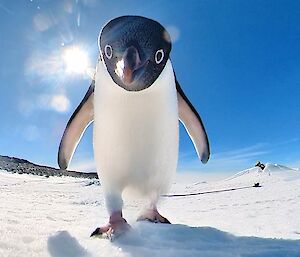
[0,164,300,257]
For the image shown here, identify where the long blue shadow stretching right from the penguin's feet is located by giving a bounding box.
[112,222,300,257]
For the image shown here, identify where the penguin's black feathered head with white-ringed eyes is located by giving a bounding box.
[98,16,171,91]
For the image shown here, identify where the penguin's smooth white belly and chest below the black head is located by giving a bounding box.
[94,62,178,199]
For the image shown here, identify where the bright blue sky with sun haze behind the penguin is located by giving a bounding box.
[0,0,300,172]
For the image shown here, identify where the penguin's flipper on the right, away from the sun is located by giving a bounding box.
[175,78,210,163]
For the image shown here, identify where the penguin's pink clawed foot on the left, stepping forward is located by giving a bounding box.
[91,212,130,241]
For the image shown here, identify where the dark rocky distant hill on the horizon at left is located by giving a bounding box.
[0,155,98,179]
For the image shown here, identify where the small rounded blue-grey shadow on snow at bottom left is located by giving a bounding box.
[47,231,90,257]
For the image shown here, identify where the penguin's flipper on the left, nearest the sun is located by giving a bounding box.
[58,80,95,170]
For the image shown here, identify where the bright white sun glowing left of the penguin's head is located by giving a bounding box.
[62,46,89,74]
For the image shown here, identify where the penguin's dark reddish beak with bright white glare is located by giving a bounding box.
[115,46,145,86]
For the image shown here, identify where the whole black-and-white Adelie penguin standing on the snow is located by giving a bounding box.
[58,16,210,237]
